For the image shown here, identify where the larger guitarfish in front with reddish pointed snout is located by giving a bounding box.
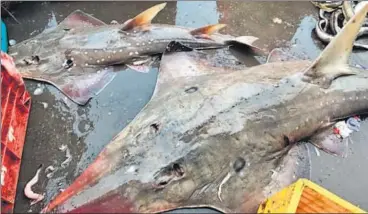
[43,3,368,213]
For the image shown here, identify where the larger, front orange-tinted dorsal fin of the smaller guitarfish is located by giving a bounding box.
[121,3,166,31]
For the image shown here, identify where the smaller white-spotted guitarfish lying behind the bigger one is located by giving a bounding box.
[10,3,260,105]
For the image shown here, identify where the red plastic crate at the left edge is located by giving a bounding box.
[1,52,31,213]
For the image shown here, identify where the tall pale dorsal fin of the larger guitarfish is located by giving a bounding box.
[304,2,368,88]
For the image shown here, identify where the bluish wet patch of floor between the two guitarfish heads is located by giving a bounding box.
[74,68,158,176]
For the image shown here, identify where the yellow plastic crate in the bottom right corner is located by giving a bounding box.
[258,179,367,213]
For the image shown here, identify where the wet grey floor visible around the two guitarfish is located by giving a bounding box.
[5,1,368,212]
